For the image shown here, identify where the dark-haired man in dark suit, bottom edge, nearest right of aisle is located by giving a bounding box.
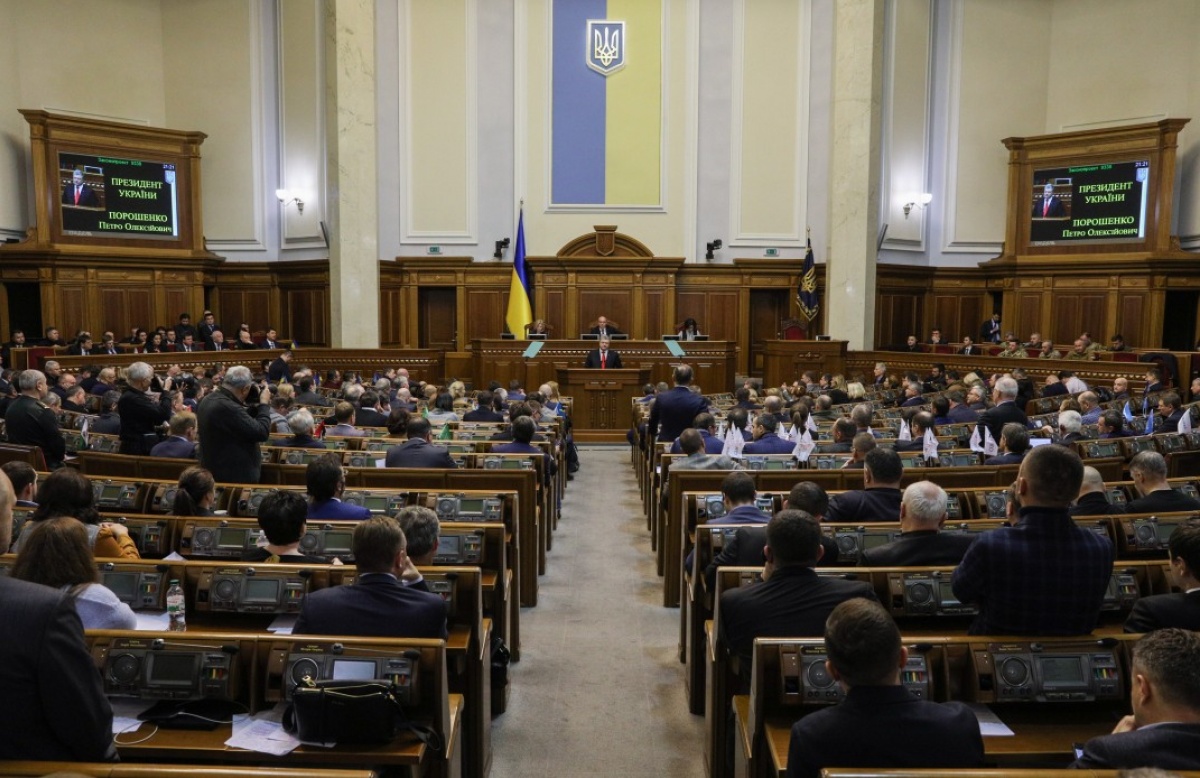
[787,599,984,778]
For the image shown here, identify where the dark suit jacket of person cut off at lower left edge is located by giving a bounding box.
[0,575,116,761]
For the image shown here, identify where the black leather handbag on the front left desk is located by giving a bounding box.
[283,677,442,752]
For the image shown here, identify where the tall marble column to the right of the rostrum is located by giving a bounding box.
[821,0,884,349]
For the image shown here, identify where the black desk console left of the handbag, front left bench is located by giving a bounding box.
[101,638,238,700]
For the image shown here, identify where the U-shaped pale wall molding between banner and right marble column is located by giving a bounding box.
[726,0,812,249]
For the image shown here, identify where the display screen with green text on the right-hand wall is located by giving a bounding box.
[1030,160,1150,246]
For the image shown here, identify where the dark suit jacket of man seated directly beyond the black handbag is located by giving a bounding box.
[292,573,448,639]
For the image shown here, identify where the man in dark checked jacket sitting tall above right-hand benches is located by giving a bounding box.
[952,445,1114,635]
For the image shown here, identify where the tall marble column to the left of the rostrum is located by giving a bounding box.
[325,0,379,348]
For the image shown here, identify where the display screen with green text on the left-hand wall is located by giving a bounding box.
[58,151,179,240]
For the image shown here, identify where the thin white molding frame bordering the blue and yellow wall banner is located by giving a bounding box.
[547,0,672,214]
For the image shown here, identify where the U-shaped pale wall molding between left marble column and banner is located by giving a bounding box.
[398,0,479,245]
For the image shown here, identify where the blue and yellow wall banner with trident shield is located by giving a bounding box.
[551,0,662,207]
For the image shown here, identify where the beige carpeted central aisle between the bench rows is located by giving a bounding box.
[492,445,704,778]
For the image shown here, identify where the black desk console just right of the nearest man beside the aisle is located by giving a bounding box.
[972,641,1124,702]
